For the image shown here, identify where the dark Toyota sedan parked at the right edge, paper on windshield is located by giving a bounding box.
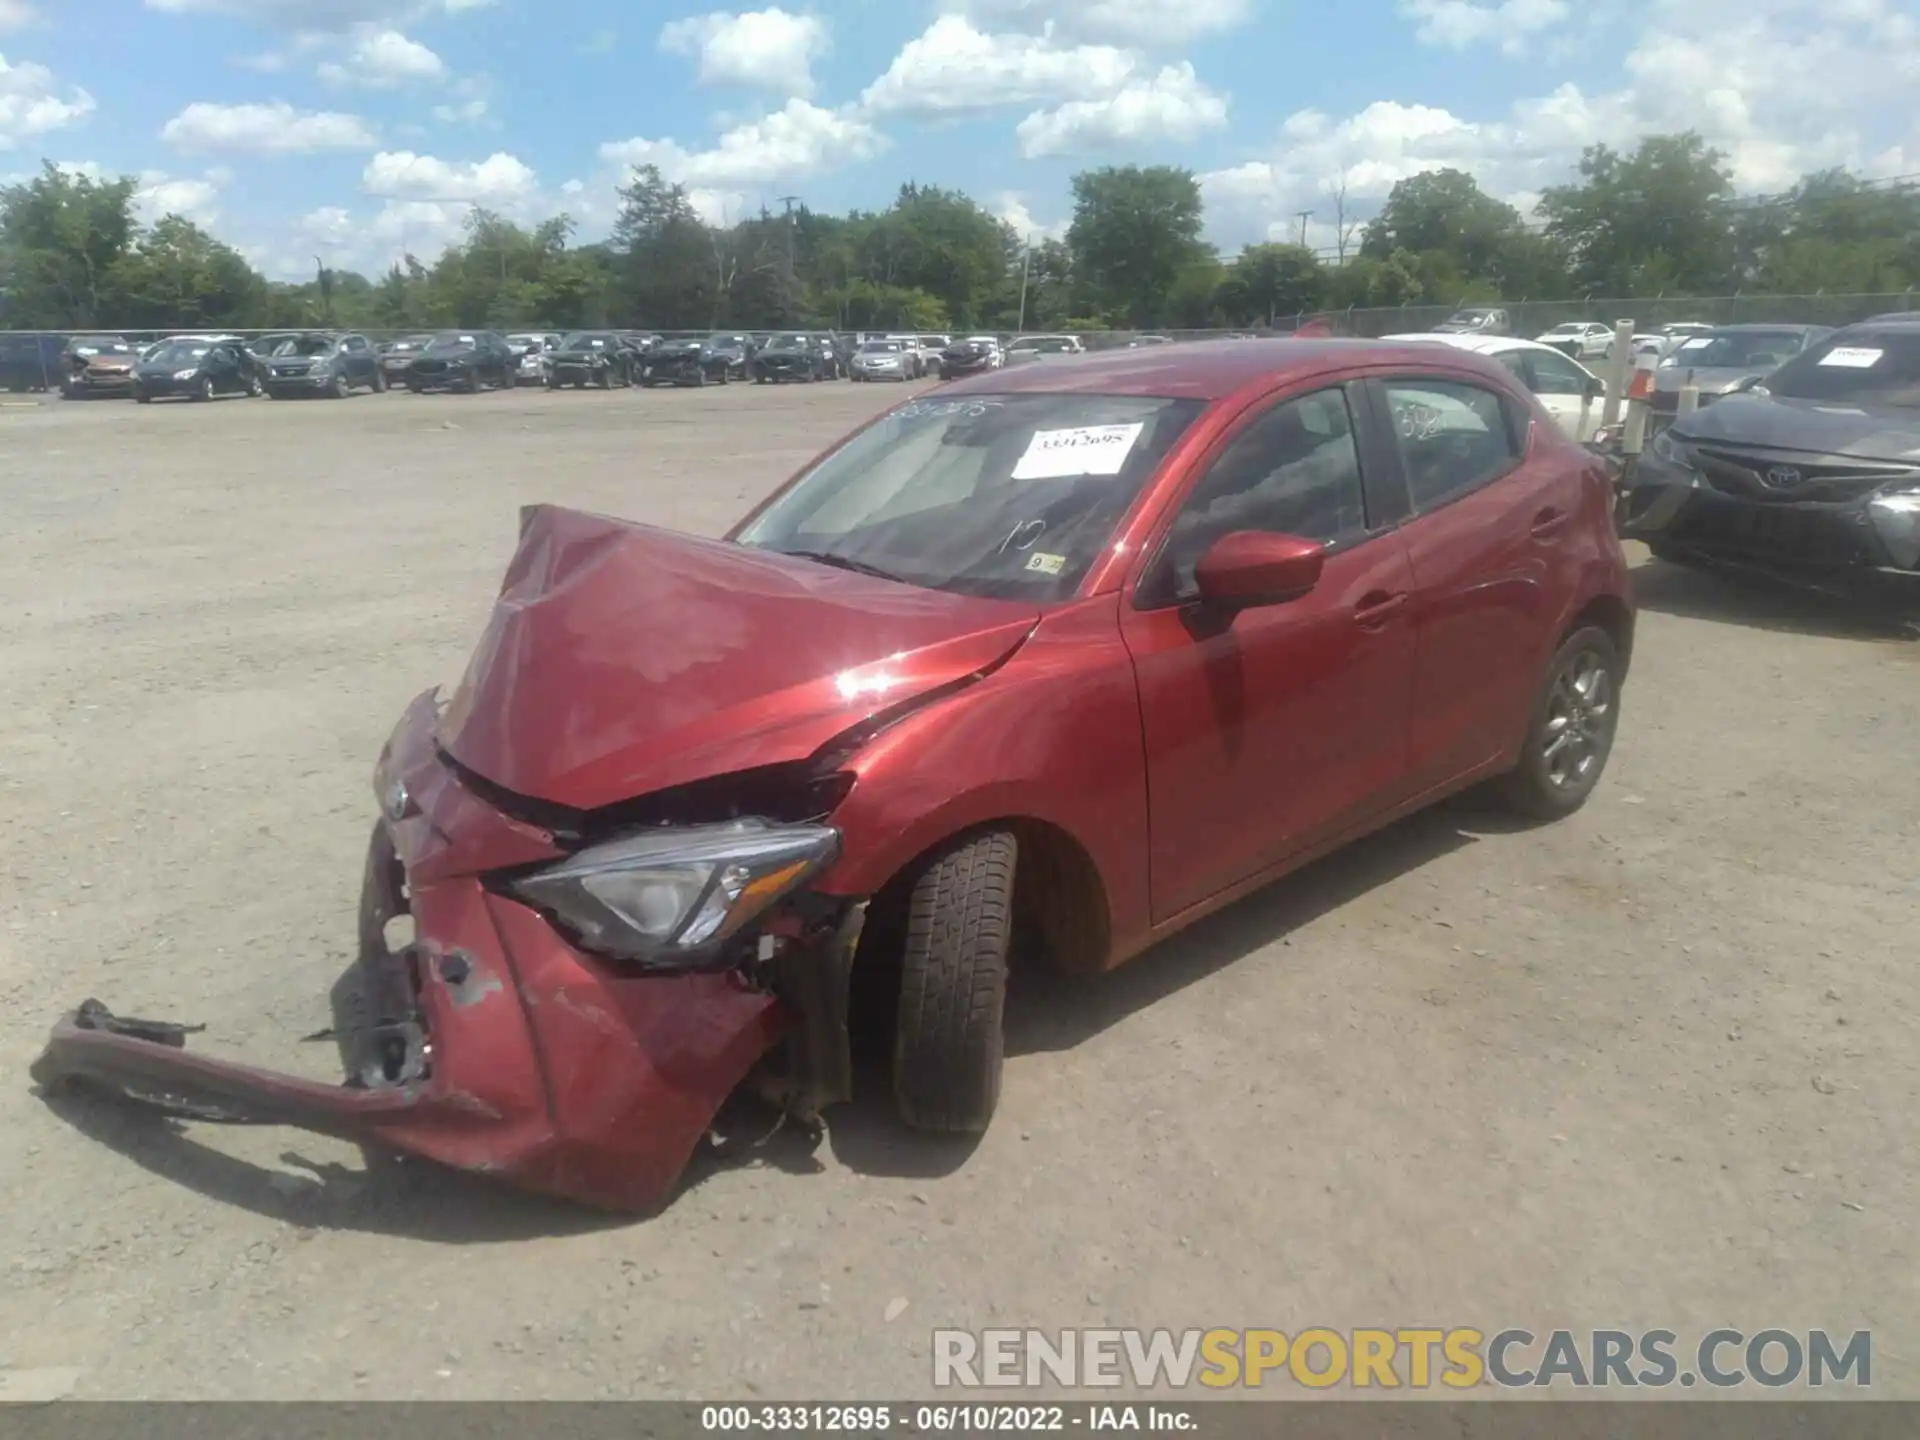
[1620,315,1920,584]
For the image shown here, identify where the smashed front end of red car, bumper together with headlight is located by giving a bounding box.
[33,693,866,1212]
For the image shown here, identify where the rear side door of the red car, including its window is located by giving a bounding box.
[1367,374,1582,795]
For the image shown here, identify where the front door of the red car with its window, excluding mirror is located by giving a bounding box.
[1121,386,1413,924]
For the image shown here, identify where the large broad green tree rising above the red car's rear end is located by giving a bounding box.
[1540,131,1736,296]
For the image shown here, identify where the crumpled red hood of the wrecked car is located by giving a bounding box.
[440,505,1039,810]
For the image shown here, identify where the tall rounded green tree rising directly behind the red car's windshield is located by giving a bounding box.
[1068,165,1208,324]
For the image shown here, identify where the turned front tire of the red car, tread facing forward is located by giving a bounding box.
[893,829,1020,1135]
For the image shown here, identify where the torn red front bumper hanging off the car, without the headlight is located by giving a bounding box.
[33,693,829,1212]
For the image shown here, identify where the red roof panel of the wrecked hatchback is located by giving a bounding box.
[943,336,1520,399]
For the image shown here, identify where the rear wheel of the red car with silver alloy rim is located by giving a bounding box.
[1498,626,1620,820]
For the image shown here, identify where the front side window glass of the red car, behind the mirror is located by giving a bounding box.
[1139,388,1367,607]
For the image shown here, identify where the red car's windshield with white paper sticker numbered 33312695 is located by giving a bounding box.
[739,394,1206,601]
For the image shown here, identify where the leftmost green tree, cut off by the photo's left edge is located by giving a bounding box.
[0,161,138,328]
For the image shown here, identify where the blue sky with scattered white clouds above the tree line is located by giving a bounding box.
[0,0,1920,275]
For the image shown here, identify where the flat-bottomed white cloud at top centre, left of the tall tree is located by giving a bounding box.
[860,15,1137,115]
